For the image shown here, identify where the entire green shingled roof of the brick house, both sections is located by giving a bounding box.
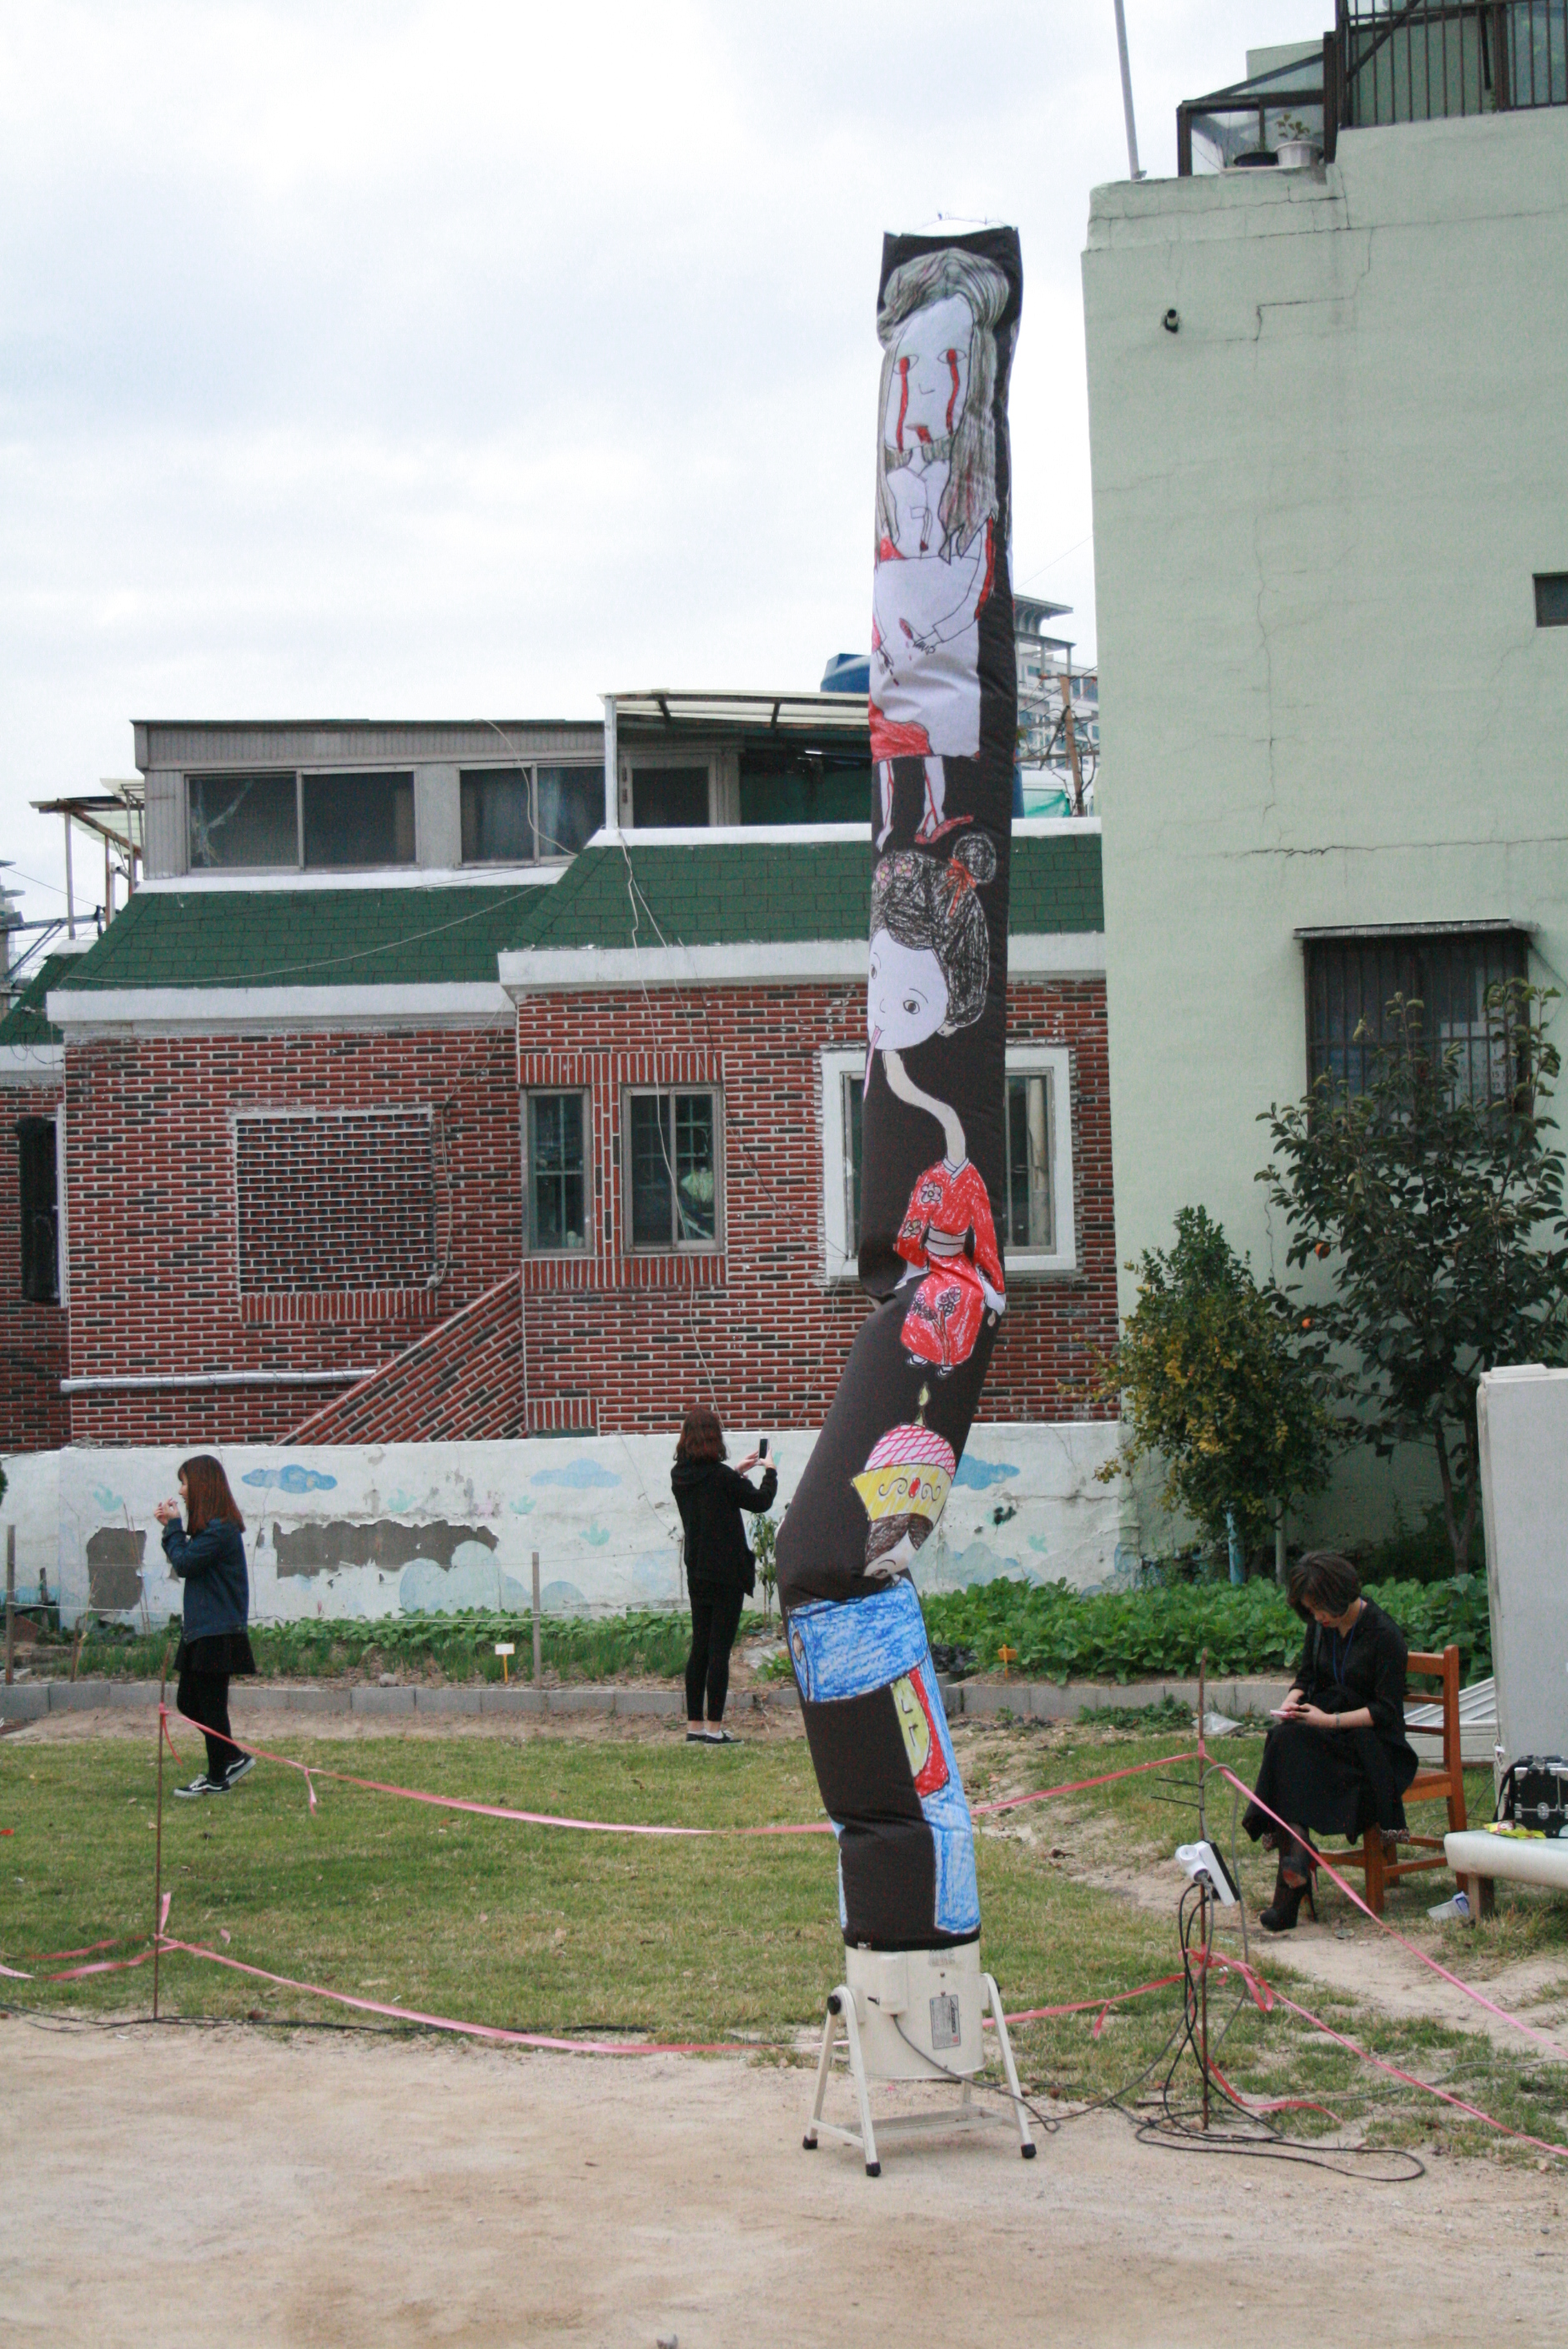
[46,832,1106,995]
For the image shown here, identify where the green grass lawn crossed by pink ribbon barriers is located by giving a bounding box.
[0,1724,1568,2150]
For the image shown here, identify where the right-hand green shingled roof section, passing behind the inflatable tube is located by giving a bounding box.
[521,832,1106,947]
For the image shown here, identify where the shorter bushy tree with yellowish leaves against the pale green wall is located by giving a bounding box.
[1098,1207,1335,1569]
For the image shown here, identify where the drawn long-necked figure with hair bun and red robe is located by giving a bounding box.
[867,832,1007,1376]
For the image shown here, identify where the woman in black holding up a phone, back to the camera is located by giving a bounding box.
[669,1407,779,1745]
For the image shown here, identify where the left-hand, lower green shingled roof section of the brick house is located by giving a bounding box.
[57,883,551,993]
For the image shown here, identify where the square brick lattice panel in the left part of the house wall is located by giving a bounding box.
[234,1109,436,1296]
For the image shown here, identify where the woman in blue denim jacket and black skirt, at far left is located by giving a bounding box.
[158,1451,256,1794]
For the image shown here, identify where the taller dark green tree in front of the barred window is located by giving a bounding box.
[1259,979,1568,1574]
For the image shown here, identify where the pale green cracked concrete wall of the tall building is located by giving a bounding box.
[1084,108,1568,1529]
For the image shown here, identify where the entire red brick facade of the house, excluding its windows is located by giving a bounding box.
[55,982,1115,1442]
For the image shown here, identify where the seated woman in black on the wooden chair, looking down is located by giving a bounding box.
[1242,1551,1415,1934]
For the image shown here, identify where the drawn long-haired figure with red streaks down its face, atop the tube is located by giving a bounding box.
[871,247,1007,848]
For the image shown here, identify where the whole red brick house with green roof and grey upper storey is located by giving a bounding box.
[0,696,1115,1445]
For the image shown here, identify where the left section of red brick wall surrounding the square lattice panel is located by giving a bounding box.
[66,1027,524,1445]
